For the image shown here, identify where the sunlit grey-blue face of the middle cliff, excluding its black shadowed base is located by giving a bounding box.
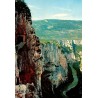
[42,43,67,86]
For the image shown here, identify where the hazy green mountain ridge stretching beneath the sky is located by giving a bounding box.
[33,19,82,40]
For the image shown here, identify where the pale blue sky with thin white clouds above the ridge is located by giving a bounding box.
[24,0,82,20]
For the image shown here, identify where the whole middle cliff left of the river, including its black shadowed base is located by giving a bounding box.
[41,43,68,98]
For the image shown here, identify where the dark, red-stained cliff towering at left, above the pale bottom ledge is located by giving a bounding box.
[15,0,42,98]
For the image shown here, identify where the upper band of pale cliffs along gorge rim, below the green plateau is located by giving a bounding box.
[41,40,82,68]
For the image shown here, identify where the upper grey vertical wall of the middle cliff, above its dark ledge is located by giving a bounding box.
[41,43,67,67]
